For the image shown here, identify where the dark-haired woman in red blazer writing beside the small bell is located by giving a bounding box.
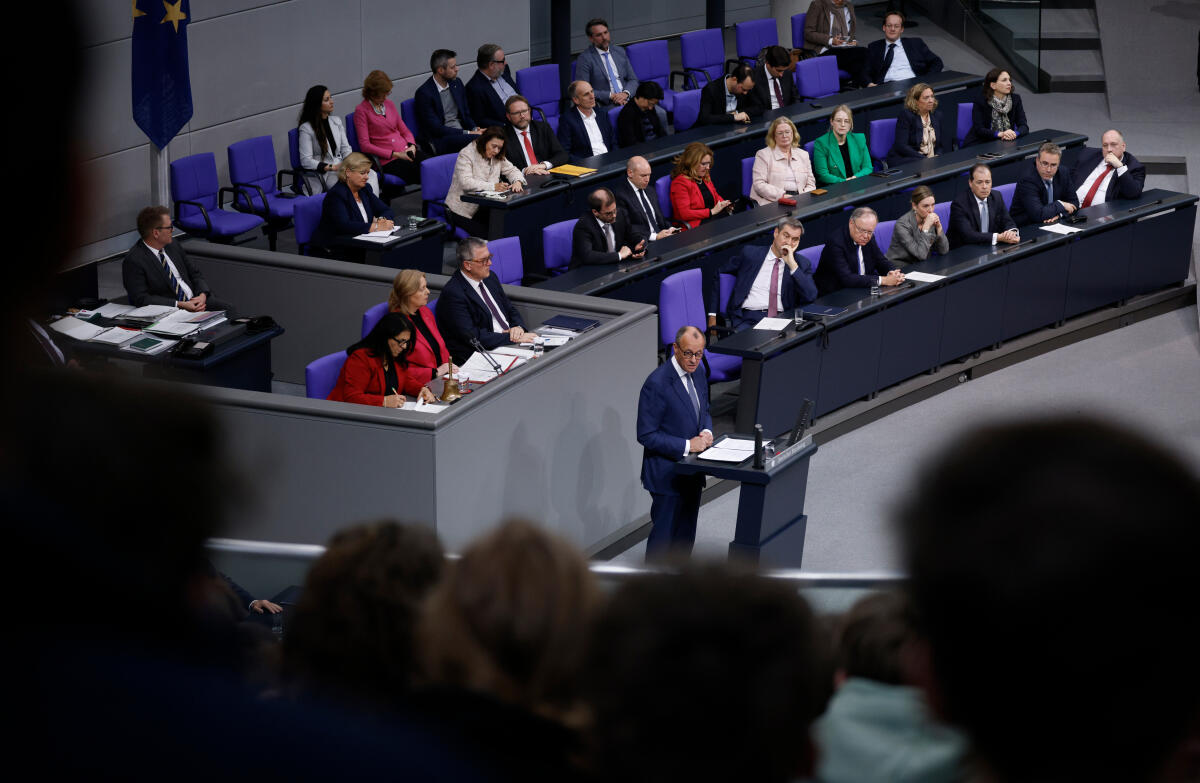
[326,312,433,408]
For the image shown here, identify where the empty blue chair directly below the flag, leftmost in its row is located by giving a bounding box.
[170,153,265,243]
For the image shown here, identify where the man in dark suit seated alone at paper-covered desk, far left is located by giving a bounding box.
[121,207,224,312]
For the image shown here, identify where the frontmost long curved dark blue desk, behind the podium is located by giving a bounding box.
[709,190,1200,432]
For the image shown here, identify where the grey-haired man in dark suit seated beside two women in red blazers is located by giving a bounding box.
[437,237,534,364]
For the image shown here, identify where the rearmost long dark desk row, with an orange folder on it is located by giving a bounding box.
[463,71,983,270]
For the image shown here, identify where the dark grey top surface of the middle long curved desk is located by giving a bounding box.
[534,130,1087,298]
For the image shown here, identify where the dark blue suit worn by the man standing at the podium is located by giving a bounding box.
[638,357,713,558]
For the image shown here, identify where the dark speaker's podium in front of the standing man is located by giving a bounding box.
[676,438,817,568]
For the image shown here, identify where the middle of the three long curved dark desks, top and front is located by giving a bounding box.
[535,130,1087,304]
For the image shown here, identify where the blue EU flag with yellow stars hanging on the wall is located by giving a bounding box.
[132,0,192,149]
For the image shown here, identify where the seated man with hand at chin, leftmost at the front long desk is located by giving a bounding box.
[708,217,817,331]
